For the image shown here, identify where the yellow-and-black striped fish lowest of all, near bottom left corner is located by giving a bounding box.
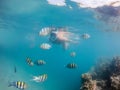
[8,81,27,90]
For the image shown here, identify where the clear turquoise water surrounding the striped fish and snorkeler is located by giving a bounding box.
[0,0,120,90]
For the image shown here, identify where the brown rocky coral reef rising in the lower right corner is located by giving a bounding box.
[80,56,120,90]
